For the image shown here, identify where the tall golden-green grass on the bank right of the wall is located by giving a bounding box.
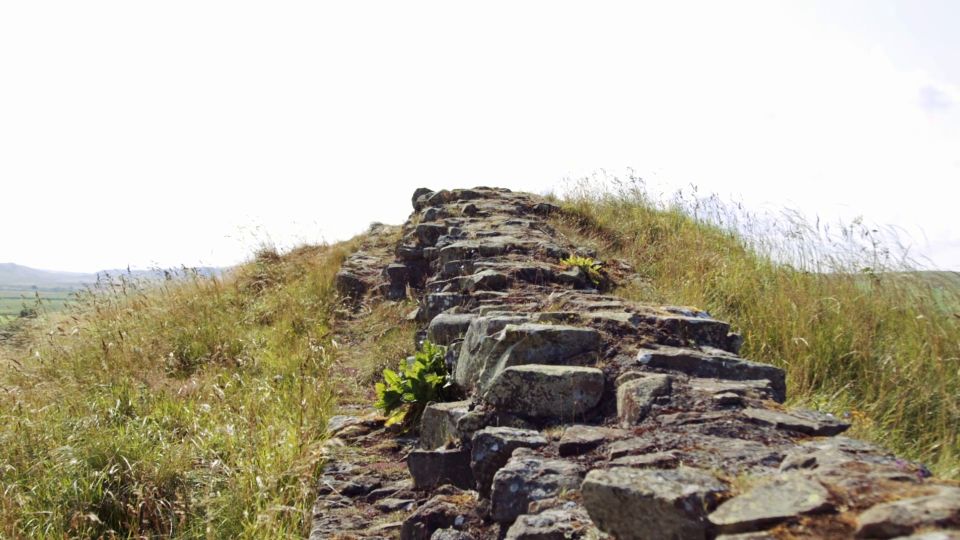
[560,178,960,478]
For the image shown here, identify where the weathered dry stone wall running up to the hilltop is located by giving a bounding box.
[322,188,960,540]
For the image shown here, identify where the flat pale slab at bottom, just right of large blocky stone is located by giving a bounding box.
[709,475,832,533]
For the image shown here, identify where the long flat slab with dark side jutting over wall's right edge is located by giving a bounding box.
[637,347,787,403]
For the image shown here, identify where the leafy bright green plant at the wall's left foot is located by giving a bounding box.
[376,341,453,430]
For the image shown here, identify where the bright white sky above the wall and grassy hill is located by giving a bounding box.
[0,0,960,270]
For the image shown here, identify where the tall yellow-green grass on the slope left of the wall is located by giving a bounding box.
[0,245,350,538]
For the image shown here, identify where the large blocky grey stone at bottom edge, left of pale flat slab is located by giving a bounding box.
[581,467,727,540]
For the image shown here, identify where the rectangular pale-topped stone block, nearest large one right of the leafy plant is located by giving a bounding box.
[483,364,603,420]
